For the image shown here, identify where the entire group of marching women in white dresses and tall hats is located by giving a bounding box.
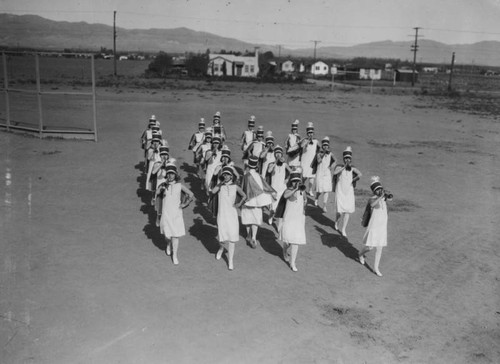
[141,112,392,276]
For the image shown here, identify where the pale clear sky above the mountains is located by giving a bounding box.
[0,0,500,49]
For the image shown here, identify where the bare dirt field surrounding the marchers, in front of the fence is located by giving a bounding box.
[0,85,500,364]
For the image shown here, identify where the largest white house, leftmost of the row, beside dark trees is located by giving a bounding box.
[207,52,259,77]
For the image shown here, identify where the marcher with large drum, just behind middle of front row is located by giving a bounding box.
[241,155,276,249]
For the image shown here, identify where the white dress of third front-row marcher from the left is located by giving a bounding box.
[280,191,306,245]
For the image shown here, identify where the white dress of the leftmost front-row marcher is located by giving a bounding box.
[160,183,186,239]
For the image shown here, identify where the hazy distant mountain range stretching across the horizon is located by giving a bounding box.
[0,14,500,66]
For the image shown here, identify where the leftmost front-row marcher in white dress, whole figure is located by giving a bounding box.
[157,163,194,265]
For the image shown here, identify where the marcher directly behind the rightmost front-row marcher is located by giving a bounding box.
[333,147,361,237]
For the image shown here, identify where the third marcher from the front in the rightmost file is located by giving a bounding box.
[313,136,335,212]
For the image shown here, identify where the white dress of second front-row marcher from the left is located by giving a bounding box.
[217,184,240,243]
